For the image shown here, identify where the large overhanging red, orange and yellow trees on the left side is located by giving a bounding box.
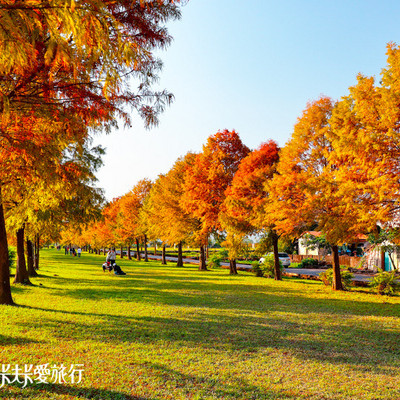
[0,0,184,304]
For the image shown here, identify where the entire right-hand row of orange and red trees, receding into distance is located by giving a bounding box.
[65,44,400,290]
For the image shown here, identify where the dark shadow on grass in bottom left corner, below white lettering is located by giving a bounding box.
[0,382,147,400]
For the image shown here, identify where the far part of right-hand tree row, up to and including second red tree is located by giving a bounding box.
[63,130,281,279]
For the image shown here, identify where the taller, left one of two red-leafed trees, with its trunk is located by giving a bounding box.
[181,130,249,269]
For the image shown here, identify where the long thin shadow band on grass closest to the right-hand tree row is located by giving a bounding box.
[51,276,400,317]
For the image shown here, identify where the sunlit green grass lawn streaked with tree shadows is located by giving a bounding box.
[0,250,400,400]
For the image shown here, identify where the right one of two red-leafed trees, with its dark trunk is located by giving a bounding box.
[220,140,281,280]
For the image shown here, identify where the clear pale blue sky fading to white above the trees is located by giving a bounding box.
[92,0,400,200]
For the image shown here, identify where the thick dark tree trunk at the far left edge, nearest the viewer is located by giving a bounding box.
[0,185,14,305]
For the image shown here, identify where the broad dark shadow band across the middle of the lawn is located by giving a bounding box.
[18,300,400,374]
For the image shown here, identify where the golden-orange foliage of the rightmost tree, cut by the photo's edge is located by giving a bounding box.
[331,44,400,231]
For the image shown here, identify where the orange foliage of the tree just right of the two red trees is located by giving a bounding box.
[267,97,347,244]
